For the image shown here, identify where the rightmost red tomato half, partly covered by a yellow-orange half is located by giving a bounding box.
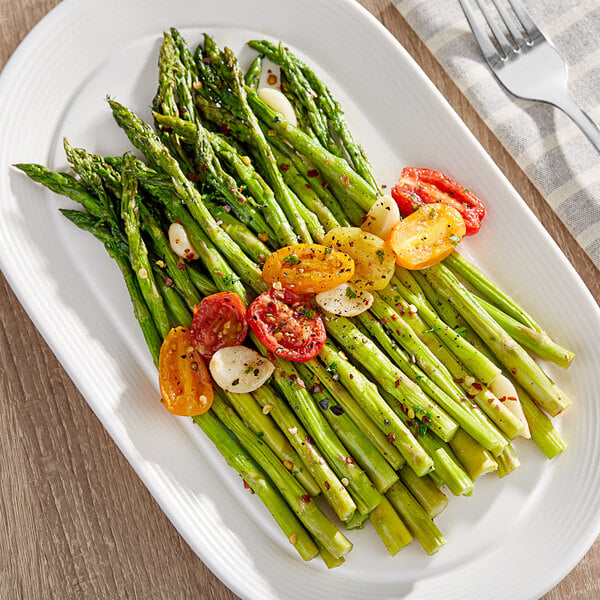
[392,167,485,235]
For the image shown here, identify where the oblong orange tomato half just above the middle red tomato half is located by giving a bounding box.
[263,244,354,294]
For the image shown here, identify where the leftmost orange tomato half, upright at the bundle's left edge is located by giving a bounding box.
[158,327,214,417]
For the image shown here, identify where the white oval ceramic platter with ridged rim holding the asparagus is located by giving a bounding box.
[0,0,600,600]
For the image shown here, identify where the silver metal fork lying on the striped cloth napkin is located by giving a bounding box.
[459,0,600,151]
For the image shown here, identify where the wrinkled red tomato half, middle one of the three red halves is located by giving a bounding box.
[248,288,326,362]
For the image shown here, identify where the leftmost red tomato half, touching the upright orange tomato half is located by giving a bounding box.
[190,292,248,360]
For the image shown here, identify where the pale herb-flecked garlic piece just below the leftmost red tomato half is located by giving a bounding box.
[209,346,275,394]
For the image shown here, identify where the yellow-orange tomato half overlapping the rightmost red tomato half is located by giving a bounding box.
[388,203,466,270]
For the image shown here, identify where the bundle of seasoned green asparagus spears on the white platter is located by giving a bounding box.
[17,29,573,567]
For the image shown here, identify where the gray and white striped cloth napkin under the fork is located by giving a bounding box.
[395,0,600,267]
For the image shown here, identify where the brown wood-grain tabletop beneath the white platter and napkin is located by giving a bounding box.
[0,0,600,600]
